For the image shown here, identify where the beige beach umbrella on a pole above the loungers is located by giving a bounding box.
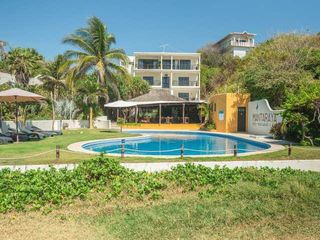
[0,88,45,142]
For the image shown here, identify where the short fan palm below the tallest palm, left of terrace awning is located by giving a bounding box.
[76,75,108,128]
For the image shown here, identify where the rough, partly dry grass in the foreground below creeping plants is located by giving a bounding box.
[0,170,320,240]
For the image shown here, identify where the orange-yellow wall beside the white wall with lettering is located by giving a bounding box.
[209,93,250,132]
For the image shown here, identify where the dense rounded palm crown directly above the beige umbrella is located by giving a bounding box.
[4,48,43,86]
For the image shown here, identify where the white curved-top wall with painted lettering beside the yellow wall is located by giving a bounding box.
[248,99,283,134]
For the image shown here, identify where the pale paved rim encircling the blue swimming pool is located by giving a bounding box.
[68,129,287,158]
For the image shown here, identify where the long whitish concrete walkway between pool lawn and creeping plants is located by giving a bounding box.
[0,159,320,172]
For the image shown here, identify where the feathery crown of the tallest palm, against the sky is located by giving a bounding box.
[63,17,128,106]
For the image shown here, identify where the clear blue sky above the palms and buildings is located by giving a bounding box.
[0,0,320,60]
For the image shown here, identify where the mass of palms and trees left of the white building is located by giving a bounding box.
[0,17,149,126]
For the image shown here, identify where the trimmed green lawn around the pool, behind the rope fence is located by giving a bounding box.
[0,129,320,165]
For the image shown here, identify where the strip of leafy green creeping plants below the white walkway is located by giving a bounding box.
[0,156,312,213]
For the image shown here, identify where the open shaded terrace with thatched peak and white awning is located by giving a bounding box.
[105,89,203,124]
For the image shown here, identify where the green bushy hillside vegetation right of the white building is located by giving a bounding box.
[199,34,320,145]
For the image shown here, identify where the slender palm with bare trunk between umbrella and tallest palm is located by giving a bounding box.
[39,55,68,130]
